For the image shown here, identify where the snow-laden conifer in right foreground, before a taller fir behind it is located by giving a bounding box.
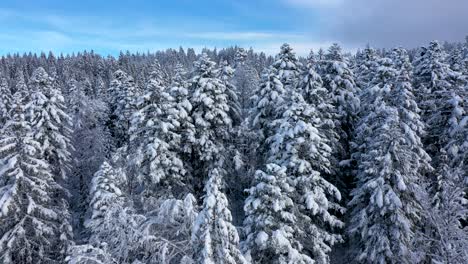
[348,100,427,264]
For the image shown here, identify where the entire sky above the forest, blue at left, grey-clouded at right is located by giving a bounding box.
[0,0,468,55]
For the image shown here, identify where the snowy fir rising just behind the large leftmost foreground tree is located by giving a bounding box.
[26,68,72,180]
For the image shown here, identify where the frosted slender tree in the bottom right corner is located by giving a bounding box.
[419,150,468,263]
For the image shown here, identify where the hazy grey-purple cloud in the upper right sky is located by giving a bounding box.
[285,0,468,47]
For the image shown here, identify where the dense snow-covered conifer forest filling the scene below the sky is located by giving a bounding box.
[0,37,468,264]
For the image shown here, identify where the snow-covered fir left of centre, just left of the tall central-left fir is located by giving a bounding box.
[130,60,187,196]
